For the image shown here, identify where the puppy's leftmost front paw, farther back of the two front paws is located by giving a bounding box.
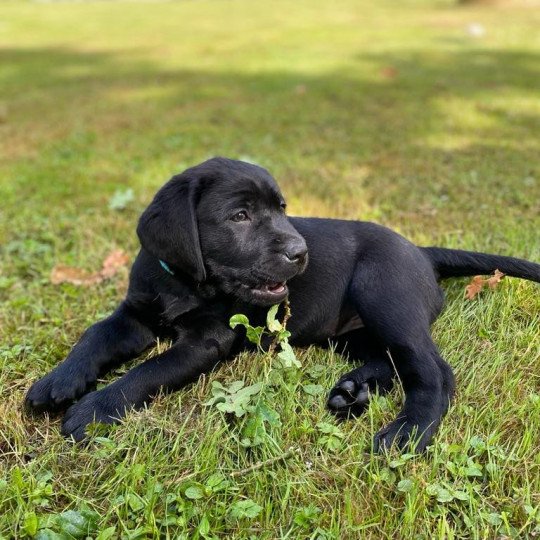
[25,364,96,412]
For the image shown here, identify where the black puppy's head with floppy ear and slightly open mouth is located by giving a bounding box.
[137,158,307,305]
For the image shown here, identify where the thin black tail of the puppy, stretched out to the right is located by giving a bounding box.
[420,247,540,283]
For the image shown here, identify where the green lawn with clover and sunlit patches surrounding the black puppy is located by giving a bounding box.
[0,0,540,540]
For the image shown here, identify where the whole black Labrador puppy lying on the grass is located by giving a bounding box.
[26,158,540,451]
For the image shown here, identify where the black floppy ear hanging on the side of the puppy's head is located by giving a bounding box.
[137,173,206,282]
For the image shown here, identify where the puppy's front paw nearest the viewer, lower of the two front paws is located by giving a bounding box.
[62,388,131,442]
